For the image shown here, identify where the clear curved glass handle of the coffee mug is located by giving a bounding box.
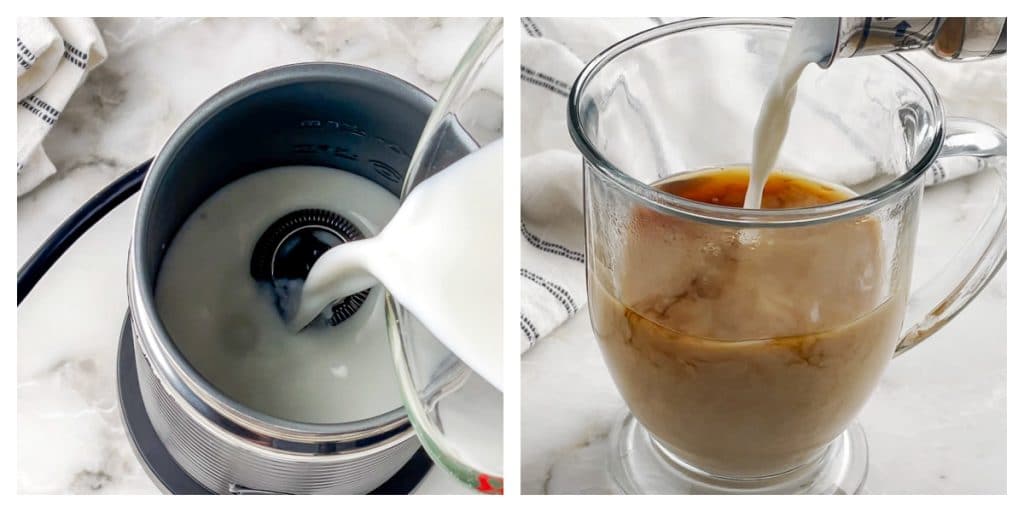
[895,117,1007,355]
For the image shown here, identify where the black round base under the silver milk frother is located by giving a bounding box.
[117,317,433,495]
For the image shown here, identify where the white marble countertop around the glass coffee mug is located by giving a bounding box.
[521,40,1007,494]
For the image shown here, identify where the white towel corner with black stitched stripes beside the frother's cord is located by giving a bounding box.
[17,17,106,197]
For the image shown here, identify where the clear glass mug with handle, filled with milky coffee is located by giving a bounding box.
[568,19,1006,494]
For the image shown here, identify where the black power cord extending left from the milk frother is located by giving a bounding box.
[17,159,153,305]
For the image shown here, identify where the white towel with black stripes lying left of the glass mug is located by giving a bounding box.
[519,17,658,351]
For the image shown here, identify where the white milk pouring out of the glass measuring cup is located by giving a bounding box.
[292,139,503,389]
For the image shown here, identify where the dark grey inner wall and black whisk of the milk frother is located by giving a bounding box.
[135,63,477,335]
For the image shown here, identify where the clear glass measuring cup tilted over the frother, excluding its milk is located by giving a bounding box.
[385,18,504,494]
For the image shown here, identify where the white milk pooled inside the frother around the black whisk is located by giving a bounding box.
[157,166,401,423]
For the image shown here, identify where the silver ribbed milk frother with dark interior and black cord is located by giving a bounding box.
[18,62,474,494]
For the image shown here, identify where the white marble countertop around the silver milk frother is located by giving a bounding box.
[17,18,491,494]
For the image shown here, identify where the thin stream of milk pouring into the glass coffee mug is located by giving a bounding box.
[743,17,835,208]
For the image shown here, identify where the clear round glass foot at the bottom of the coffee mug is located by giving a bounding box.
[608,413,867,495]
